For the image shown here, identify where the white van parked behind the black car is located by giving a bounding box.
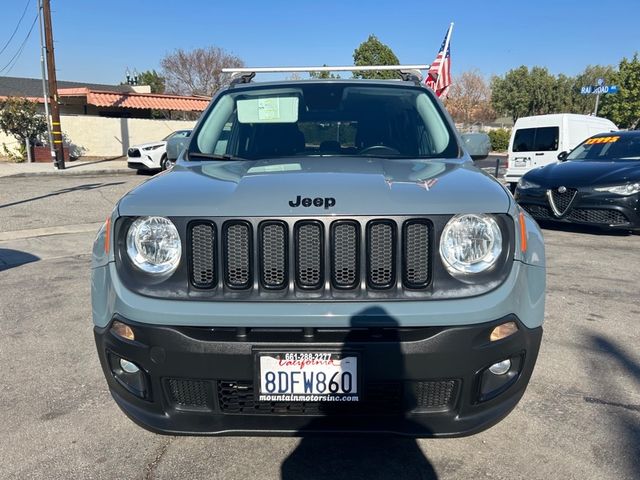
[504,113,618,191]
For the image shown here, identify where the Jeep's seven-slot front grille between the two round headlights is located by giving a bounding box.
[187,218,434,298]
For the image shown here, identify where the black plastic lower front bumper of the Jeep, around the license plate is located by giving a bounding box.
[95,316,542,437]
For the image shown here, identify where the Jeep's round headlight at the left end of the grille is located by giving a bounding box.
[127,217,182,274]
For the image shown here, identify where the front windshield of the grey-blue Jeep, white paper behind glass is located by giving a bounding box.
[189,83,458,160]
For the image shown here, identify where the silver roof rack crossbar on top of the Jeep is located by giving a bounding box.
[222,65,431,85]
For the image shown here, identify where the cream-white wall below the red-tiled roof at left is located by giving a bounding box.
[0,115,195,157]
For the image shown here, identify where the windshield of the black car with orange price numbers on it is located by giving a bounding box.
[567,135,640,161]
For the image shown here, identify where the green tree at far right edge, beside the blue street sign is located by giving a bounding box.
[598,53,640,129]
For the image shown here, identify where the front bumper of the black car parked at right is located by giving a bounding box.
[515,188,640,230]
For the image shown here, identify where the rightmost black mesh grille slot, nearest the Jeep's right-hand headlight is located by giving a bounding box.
[403,222,431,288]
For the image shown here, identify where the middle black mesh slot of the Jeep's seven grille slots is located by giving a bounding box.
[296,223,323,288]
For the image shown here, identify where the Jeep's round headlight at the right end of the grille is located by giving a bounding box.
[440,214,502,275]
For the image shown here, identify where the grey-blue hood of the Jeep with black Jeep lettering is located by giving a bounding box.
[118,157,511,217]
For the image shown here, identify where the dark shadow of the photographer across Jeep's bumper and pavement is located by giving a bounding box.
[281,307,438,480]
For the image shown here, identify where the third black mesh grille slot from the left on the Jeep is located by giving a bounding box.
[260,223,287,288]
